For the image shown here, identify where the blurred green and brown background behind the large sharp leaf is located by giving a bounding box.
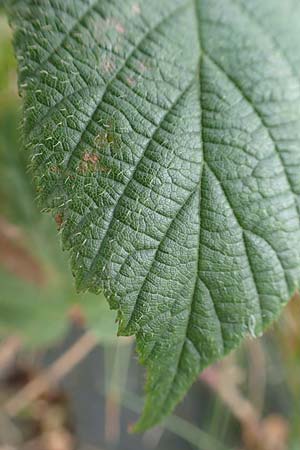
[0,6,300,450]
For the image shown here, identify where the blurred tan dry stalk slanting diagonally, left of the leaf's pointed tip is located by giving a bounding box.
[4,331,98,416]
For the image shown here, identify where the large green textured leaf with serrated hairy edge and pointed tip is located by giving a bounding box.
[5,0,300,430]
